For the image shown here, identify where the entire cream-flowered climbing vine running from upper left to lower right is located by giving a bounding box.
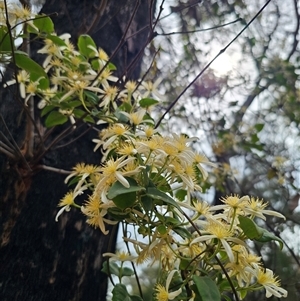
[0,2,287,301]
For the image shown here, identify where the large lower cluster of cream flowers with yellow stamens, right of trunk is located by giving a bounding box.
[58,108,287,301]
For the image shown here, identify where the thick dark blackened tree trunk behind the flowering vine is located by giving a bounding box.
[0,0,151,301]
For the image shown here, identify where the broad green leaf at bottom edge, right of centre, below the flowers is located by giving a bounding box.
[193,275,221,301]
